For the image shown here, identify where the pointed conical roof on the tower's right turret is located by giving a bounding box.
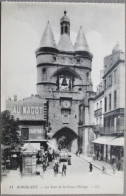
[74,26,89,52]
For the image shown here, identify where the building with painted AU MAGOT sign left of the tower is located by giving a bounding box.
[6,95,47,150]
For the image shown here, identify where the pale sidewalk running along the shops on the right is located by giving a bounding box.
[77,155,124,178]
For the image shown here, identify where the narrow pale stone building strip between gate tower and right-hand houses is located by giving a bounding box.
[78,91,96,156]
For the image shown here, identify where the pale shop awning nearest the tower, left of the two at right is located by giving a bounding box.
[92,136,115,145]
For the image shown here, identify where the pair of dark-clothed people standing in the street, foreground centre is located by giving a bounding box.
[53,162,67,176]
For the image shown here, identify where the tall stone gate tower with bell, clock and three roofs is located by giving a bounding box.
[36,11,93,152]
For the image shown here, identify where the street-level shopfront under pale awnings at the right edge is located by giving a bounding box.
[93,136,124,170]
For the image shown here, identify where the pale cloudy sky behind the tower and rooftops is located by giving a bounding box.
[1,2,125,110]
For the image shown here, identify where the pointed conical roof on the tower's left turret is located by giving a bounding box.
[40,21,57,49]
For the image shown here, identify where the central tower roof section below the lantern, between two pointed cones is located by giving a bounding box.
[58,34,74,51]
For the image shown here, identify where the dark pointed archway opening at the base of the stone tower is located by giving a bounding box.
[53,127,77,152]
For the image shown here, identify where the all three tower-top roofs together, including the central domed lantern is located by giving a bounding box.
[39,11,89,52]
